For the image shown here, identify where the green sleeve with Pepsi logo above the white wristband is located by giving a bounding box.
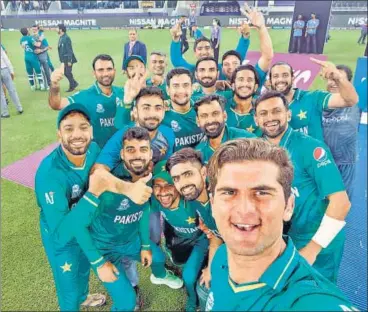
[301,139,345,198]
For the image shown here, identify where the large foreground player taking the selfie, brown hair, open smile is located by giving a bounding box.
[206,139,356,311]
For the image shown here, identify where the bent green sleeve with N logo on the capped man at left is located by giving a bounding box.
[36,181,99,246]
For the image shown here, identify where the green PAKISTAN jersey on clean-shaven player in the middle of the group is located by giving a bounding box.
[162,107,203,152]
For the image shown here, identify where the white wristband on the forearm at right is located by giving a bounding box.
[312,214,346,248]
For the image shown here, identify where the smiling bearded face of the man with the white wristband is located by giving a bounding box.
[255,97,291,138]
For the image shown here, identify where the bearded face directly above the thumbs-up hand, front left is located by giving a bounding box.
[120,139,152,176]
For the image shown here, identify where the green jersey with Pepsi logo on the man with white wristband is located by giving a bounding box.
[280,127,345,239]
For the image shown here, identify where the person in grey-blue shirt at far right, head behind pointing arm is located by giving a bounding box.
[322,65,360,200]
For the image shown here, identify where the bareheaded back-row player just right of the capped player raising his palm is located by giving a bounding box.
[146,51,169,101]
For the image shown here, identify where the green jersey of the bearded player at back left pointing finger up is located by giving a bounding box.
[68,81,123,148]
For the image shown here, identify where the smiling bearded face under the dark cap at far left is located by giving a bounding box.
[58,112,92,156]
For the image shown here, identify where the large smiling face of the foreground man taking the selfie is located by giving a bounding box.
[211,160,293,256]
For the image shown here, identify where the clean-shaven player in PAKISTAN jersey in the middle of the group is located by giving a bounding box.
[162,68,203,151]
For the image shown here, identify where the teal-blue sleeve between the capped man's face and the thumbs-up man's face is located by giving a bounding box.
[96,129,125,170]
